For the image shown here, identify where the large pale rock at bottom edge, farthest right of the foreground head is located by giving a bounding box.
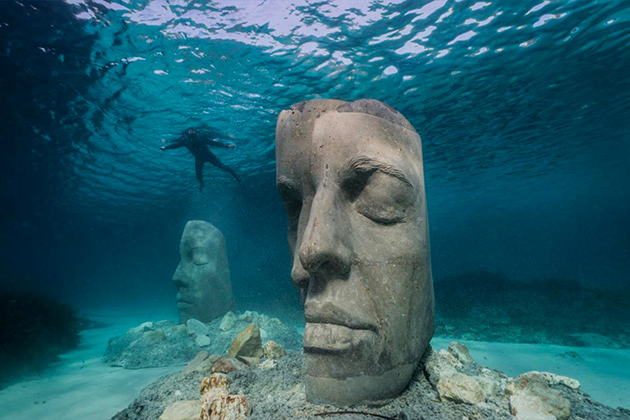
[506,376,571,420]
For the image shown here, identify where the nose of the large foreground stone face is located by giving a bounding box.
[293,188,352,287]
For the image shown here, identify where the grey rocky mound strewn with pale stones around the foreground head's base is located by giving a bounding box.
[112,343,630,420]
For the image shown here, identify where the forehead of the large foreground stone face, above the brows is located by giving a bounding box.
[276,110,422,185]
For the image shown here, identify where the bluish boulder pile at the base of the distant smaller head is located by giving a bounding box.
[103,311,302,369]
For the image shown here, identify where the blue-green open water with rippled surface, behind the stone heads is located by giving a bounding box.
[0,0,630,336]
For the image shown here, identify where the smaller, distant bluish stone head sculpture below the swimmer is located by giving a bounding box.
[173,220,234,323]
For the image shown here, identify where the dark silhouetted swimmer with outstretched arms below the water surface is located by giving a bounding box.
[160,128,241,191]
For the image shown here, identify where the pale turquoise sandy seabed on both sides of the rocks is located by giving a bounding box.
[0,308,630,420]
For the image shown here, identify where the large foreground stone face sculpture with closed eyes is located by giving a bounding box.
[276,100,433,405]
